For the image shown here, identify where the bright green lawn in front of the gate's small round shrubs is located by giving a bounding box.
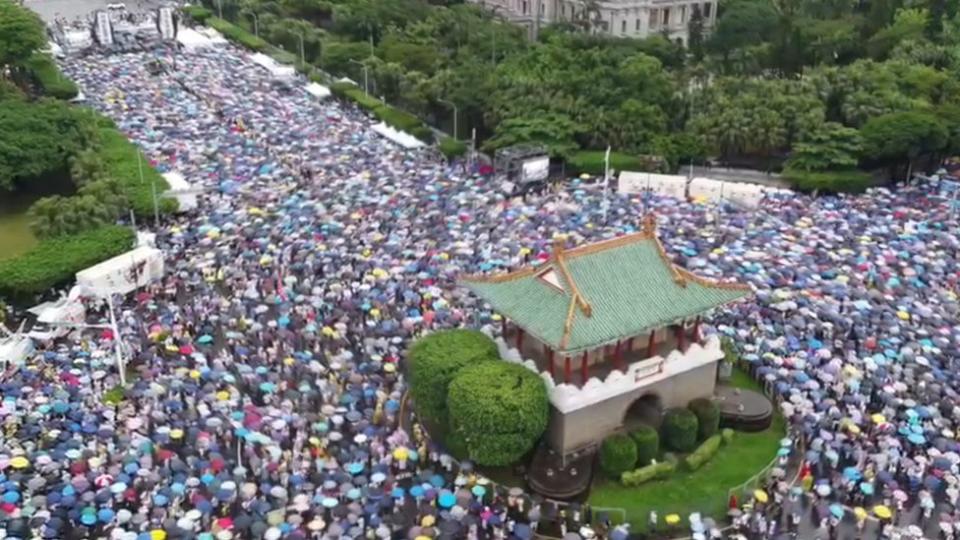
[590,371,785,532]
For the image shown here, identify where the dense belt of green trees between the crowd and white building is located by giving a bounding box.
[194,0,960,190]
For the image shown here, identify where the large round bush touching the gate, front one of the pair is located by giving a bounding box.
[447,361,550,466]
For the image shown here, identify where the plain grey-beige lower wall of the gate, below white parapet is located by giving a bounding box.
[547,361,717,453]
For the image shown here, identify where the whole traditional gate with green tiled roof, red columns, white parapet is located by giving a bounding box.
[461,215,750,456]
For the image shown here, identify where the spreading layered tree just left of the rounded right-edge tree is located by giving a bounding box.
[787,122,863,171]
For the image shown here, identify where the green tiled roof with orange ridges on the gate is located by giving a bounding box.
[460,216,751,353]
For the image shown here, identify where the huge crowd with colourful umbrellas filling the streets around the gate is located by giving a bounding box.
[0,12,960,540]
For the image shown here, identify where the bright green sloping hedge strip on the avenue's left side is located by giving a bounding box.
[97,127,178,219]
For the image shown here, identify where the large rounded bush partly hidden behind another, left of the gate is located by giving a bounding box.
[407,330,499,426]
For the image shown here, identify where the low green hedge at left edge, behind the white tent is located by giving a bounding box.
[0,225,134,298]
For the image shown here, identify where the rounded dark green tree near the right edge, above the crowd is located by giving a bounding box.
[860,111,949,176]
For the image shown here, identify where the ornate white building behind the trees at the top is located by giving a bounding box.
[471,0,717,44]
